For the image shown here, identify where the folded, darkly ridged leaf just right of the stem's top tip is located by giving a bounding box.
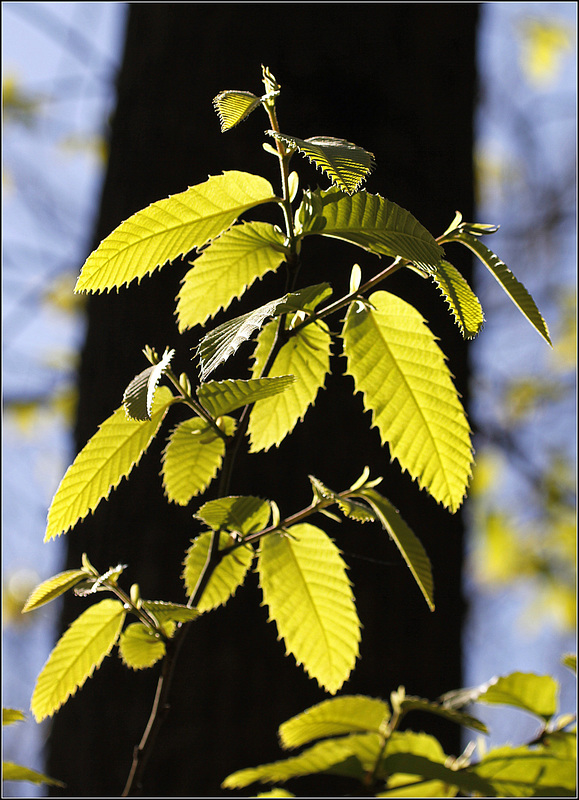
[268,131,375,195]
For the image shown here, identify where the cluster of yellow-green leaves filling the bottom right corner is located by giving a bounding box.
[223,659,576,797]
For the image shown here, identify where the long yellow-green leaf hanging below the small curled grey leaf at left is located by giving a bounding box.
[44,386,173,542]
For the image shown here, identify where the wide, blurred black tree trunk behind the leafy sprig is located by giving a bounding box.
[48,3,478,797]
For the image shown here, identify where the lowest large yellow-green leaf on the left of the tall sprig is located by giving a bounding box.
[31,599,126,722]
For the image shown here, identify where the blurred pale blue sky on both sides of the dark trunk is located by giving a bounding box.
[2,3,576,796]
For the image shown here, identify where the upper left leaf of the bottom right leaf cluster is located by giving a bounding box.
[279,695,390,748]
